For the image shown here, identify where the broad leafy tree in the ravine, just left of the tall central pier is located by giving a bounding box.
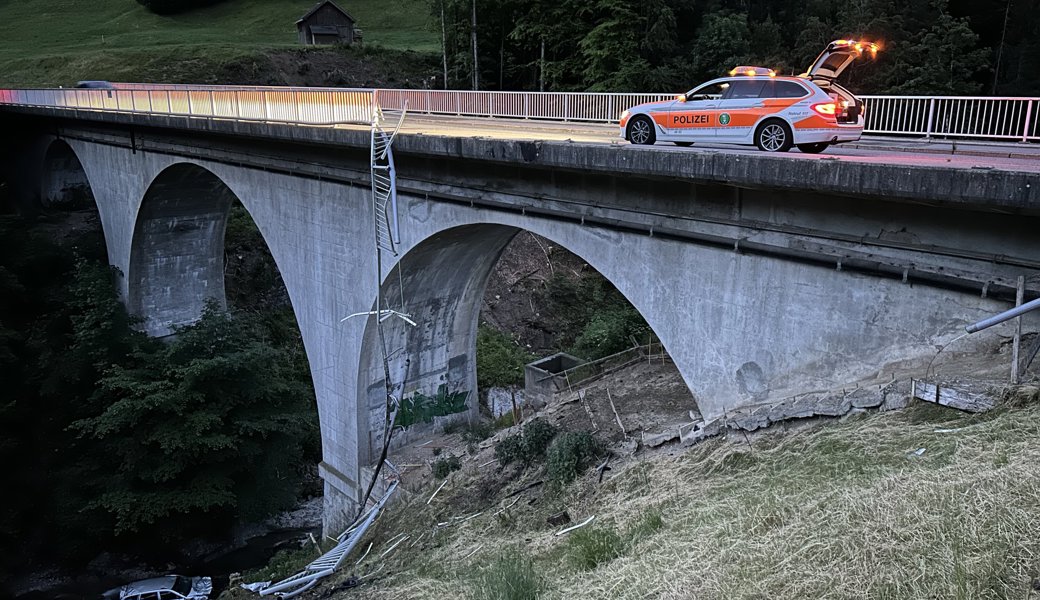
[73,305,316,538]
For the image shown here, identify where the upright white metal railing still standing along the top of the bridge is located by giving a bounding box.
[0,83,1040,141]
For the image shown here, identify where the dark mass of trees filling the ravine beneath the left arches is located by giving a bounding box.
[0,201,319,580]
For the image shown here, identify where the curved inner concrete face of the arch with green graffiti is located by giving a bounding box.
[357,221,697,464]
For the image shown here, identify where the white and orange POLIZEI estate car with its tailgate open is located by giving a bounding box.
[621,40,878,154]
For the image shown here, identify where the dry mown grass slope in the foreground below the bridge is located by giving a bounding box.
[328,390,1040,600]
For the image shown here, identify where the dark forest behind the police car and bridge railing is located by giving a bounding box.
[431,0,1040,95]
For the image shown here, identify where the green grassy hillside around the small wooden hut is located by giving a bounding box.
[0,0,438,86]
